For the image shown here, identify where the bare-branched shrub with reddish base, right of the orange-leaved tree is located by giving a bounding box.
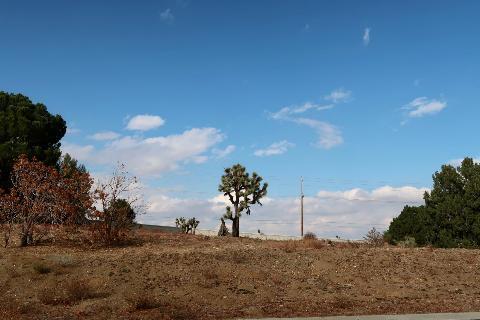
[90,163,144,244]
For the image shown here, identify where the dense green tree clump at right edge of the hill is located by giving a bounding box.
[386,158,480,248]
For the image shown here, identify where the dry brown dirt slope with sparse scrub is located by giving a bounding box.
[0,232,480,319]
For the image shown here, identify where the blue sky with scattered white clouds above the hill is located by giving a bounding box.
[0,0,480,239]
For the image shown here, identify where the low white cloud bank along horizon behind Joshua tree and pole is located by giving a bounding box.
[140,186,428,239]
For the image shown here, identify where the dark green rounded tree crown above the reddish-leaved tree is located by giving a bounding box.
[0,91,67,189]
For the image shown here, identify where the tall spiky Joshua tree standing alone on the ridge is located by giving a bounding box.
[218,164,268,237]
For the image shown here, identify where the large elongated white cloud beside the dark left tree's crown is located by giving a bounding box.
[62,128,224,176]
